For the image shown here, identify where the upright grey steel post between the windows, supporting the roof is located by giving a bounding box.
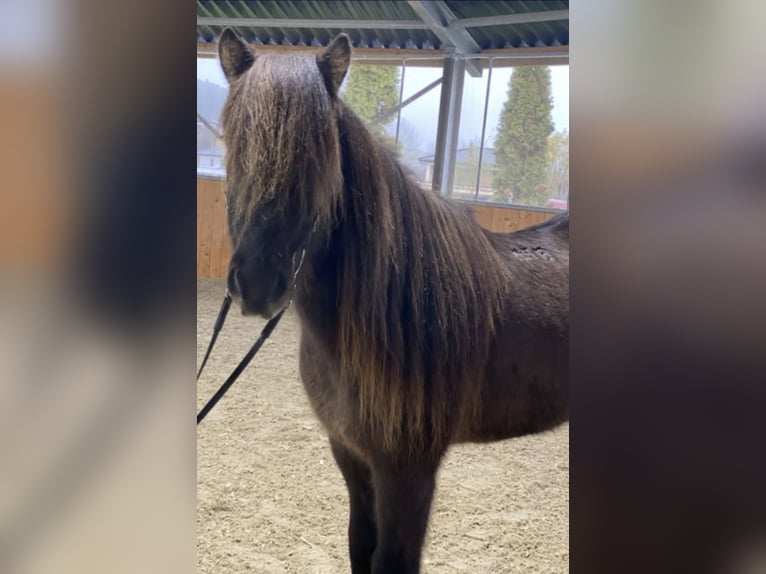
[431,54,465,196]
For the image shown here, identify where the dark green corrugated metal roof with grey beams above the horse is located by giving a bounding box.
[197,0,569,54]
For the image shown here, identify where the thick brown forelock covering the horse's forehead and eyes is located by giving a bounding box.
[222,55,341,232]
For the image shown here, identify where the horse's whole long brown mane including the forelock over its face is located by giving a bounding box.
[223,55,510,452]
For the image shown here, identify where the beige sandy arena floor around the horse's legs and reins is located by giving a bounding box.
[197,280,569,574]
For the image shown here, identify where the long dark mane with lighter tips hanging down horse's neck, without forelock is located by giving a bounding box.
[338,103,509,451]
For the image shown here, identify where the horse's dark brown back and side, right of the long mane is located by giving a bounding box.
[458,214,569,442]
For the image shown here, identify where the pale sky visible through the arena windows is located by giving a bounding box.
[197,58,569,149]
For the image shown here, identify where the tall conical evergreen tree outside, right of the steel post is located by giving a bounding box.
[493,66,553,206]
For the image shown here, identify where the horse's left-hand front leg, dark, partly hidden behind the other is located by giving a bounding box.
[330,439,377,574]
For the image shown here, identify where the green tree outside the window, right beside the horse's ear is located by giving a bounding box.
[341,64,399,143]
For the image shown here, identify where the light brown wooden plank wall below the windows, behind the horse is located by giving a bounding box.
[197,178,555,277]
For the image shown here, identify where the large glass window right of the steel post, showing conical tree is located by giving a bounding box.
[453,63,569,209]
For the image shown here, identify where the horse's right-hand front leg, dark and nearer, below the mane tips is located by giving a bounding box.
[372,465,436,574]
